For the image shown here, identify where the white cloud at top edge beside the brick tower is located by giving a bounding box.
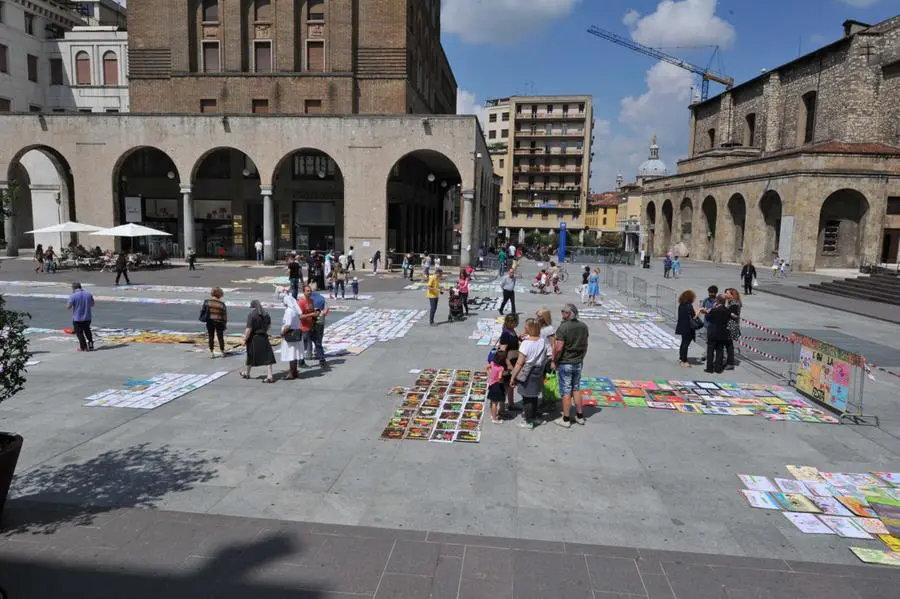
[441,0,581,44]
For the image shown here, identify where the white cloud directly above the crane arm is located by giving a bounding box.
[623,0,736,48]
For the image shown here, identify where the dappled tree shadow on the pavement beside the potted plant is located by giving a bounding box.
[2,443,221,535]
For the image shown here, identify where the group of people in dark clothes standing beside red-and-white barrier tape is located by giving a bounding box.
[675,285,743,374]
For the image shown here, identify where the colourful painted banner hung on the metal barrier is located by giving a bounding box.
[794,333,865,412]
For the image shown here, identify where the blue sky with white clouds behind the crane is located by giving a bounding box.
[441,0,900,191]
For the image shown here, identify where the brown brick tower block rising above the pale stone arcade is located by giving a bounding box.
[128,0,456,114]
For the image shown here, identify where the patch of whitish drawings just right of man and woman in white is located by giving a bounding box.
[323,307,425,355]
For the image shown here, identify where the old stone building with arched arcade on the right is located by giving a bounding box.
[642,16,900,270]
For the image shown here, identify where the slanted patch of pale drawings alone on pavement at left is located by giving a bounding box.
[84,372,228,410]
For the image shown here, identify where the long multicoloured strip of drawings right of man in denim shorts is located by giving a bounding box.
[581,377,840,424]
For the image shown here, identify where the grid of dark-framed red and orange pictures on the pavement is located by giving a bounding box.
[381,368,487,443]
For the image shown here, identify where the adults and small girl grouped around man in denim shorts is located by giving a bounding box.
[485,304,589,429]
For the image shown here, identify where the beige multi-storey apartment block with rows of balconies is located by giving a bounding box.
[485,96,594,243]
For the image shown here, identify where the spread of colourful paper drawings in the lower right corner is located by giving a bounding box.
[738,465,900,566]
